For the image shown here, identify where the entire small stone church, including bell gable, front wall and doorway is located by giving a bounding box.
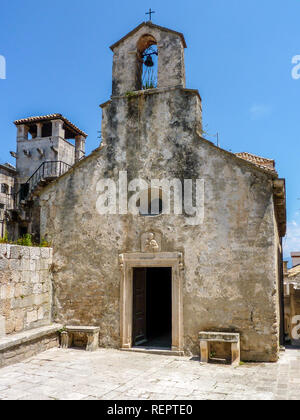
[39,22,286,361]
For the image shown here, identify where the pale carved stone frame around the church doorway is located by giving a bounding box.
[119,252,184,354]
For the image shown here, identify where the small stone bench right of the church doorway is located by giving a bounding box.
[199,332,241,365]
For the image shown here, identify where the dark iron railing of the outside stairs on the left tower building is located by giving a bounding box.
[15,161,72,206]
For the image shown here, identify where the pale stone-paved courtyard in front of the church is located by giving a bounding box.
[0,349,300,400]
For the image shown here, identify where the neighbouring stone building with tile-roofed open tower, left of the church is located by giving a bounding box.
[0,114,87,242]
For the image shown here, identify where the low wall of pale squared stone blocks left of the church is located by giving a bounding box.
[0,244,52,334]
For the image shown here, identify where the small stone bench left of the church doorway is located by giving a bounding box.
[61,326,100,351]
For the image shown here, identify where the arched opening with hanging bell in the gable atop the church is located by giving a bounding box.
[137,35,158,90]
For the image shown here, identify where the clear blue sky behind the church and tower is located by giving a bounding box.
[0,0,300,262]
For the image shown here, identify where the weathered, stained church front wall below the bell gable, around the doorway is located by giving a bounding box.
[41,89,279,361]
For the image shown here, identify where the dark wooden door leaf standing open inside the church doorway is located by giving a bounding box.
[132,268,147,346]
